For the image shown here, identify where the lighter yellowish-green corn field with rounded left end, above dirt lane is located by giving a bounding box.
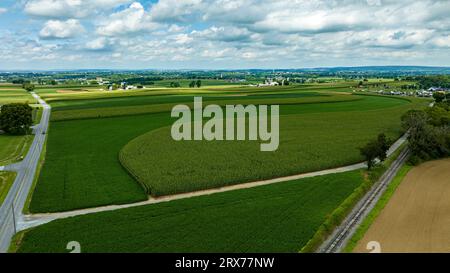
[120,100,414,196]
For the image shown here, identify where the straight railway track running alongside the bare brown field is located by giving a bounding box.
[318,149,409,253]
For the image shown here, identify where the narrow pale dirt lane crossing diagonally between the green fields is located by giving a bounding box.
[17,132,407,231]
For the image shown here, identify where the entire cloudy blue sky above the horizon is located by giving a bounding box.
[0,0,450,70]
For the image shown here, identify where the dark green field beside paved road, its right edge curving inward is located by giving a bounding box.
[30,114,170,212]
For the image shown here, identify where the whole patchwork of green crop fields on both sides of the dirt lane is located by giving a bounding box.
[0,78,428,252]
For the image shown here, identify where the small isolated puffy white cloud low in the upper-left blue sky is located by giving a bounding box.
[39,19,84,39]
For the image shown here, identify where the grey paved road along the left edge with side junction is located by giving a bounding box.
[0,92,51,253]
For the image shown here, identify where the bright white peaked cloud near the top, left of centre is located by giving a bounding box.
[97,2,159,36]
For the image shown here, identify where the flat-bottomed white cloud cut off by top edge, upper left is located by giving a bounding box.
[24,0,131,18]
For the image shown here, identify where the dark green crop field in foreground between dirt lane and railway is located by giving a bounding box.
[14,171,363,253]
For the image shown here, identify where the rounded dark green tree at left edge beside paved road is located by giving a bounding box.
[0,103,33,135]
